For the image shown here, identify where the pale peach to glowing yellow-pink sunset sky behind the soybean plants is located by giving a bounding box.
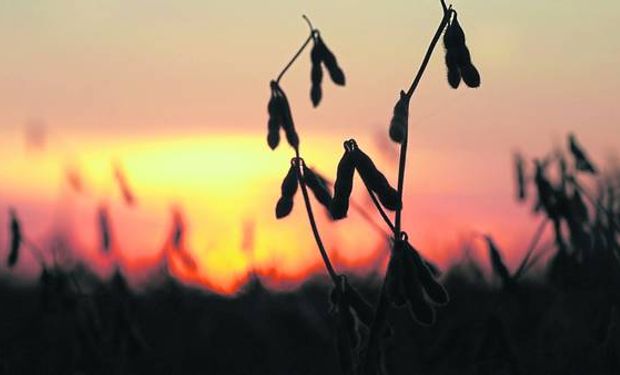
[0,0,620,292]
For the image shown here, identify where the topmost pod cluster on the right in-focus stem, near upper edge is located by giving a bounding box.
[443,11,480,89]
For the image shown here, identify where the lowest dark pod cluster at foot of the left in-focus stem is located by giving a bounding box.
[330,276,373,374]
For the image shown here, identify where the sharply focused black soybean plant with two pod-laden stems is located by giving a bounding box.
[267,0,480,375]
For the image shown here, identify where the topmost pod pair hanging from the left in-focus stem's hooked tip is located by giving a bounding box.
[310,30,345,107]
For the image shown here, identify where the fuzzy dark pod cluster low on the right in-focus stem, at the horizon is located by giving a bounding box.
[386,239,449,325]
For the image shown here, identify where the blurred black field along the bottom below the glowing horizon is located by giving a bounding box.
[0,258,620,374]
